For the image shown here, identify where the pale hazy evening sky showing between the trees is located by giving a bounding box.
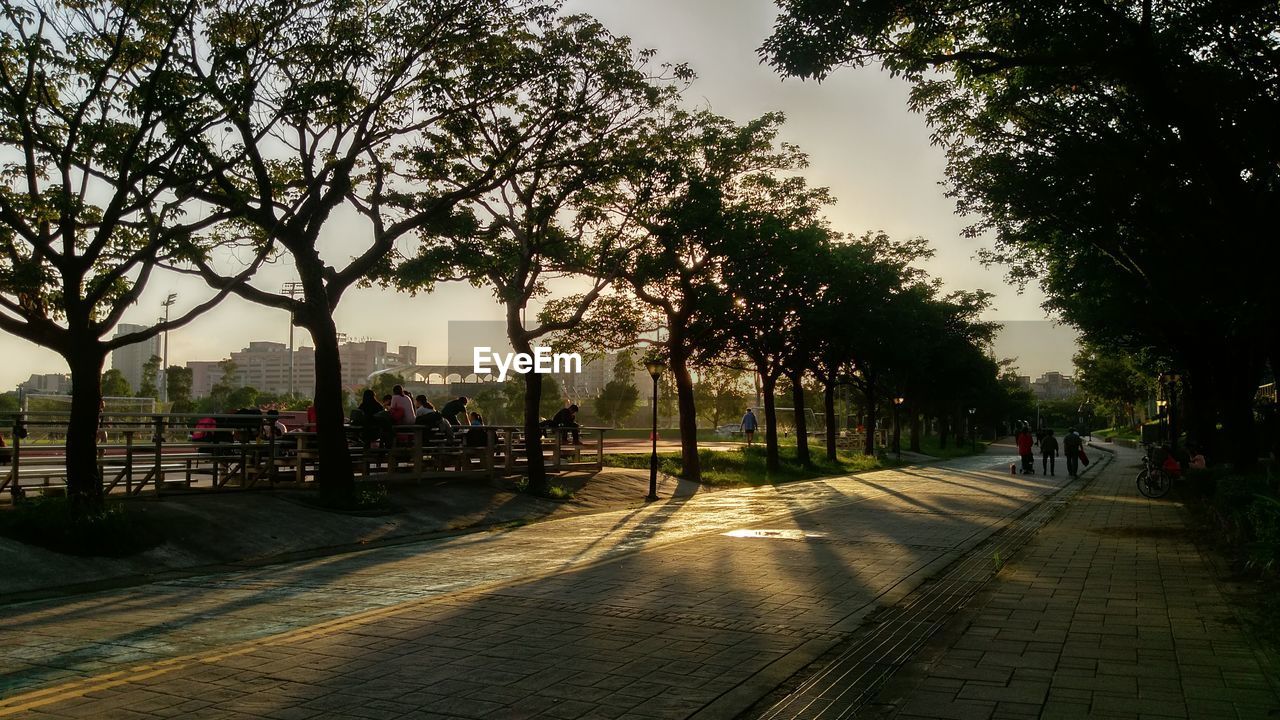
[0,0,1074,388]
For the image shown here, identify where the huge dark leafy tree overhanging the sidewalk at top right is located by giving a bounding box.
[764,0,1280,465]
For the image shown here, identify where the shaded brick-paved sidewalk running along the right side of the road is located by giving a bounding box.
[872,448,1280,720]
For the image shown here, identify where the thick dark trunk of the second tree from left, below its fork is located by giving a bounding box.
[301,311,356,507]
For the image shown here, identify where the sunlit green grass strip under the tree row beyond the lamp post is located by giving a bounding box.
[604,445,897,486]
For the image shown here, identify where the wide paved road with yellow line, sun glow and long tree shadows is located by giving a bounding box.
[0,447,1068,719]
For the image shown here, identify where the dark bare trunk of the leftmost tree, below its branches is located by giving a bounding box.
[64,342,106,511]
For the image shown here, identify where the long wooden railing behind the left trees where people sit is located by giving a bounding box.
[0,413,605,498]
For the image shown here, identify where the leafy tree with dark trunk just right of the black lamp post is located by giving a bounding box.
[595,111,805,480]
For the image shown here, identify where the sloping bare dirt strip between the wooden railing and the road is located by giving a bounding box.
[0,468,710,603]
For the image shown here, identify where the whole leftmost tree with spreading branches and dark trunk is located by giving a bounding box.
[0,0,257,509]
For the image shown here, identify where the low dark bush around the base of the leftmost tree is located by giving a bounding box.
[0,497,163,557]
